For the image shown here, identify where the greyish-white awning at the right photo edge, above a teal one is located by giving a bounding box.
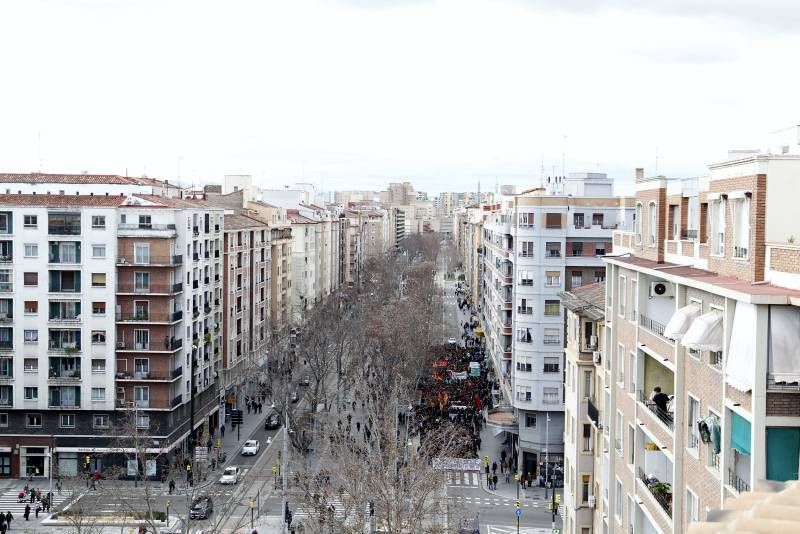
[767,306,800,384]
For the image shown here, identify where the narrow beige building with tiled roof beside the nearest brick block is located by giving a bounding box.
[561,282,606,534]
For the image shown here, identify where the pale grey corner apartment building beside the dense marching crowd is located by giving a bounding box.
[481,174,633,482]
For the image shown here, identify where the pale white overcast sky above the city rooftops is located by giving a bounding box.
[0,0,800,192]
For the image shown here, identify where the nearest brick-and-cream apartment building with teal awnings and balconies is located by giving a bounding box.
[596,151,800,534]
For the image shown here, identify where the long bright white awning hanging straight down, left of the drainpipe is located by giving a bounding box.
[725,302,756,391]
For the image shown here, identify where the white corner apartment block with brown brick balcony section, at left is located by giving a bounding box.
[0,194,222,477]
